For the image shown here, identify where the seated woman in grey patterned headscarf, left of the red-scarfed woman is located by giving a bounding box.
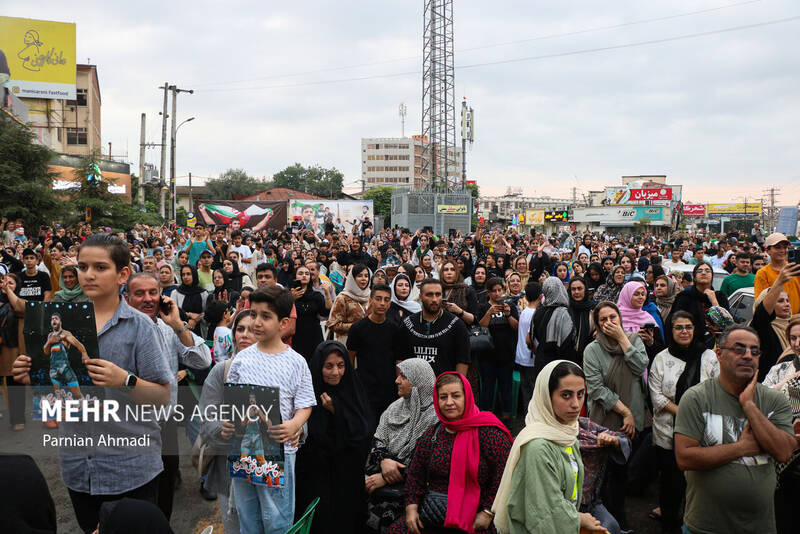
[364,358,438,530]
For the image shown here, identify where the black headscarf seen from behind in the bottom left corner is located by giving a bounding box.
[0,455,57,534]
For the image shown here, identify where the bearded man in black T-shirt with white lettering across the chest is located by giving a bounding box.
[400,278,470,376]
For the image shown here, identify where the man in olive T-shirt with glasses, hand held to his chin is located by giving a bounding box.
[674,325,797,533]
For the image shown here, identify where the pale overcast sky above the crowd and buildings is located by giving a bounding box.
[2,0,800,204]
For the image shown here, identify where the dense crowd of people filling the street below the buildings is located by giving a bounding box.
[0,215,800,534]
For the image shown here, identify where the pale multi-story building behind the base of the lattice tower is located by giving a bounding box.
[361,135,461,189]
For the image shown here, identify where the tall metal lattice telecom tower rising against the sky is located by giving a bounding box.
[421,0,460,190]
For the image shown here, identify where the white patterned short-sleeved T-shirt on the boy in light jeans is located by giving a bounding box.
[228,344,317,453]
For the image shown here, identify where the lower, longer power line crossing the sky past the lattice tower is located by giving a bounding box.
[198,15,800,92]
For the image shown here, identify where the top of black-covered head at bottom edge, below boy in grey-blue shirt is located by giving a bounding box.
[99,497,174,534]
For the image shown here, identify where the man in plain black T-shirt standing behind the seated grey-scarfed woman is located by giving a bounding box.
[347,284,402,428]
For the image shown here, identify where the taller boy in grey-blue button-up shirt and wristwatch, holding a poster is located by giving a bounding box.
[13,234,171,532]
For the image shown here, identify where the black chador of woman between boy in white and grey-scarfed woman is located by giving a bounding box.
[295,341,372,534]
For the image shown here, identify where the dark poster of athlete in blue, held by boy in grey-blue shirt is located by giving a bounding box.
[23,302,100,400]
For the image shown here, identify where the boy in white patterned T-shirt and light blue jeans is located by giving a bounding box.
[222,286,316,534]
